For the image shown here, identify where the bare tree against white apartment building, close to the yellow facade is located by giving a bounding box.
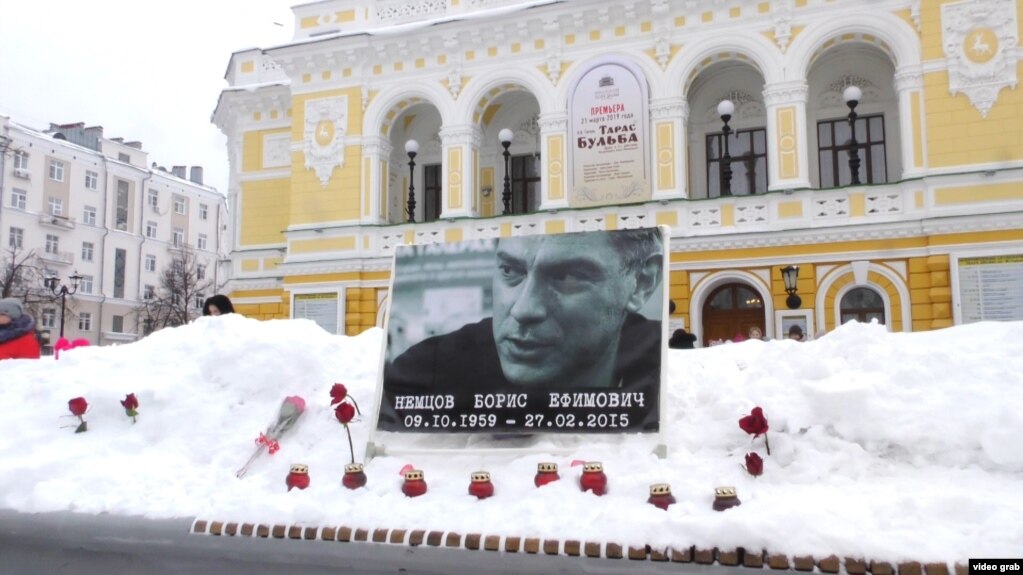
[135,247,215,335]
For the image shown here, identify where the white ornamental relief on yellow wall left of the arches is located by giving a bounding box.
[303,96,348,187]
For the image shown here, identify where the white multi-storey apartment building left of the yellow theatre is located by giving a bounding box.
[0,116,226,345]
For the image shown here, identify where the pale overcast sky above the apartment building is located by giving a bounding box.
[0,0,304,193]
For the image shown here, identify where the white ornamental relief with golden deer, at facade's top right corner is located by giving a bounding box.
[941,0,1019,118]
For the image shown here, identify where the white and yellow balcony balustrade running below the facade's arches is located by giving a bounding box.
[232,169,1006,278]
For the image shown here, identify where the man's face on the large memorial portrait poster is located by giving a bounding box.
[494,234,636,385]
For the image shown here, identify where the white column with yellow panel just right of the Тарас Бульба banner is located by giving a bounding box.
[649,96,690,200]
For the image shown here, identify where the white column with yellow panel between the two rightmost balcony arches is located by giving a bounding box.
[764,80,810,190]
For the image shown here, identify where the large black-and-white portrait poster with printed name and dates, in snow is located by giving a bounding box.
[377,228,667,433]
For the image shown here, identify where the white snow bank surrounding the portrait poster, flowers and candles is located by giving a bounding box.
[0,315,1023,563]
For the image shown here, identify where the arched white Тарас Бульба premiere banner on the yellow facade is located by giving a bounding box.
[569,57,651,207]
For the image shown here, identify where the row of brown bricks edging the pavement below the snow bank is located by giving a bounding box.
[191,520,969,575]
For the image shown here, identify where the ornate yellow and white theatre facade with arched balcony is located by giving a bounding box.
[214,0,1023,345]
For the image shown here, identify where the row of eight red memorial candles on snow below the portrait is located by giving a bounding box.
[285,461,741,512]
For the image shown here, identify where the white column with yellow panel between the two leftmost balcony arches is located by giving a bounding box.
[440,124,482,218]
